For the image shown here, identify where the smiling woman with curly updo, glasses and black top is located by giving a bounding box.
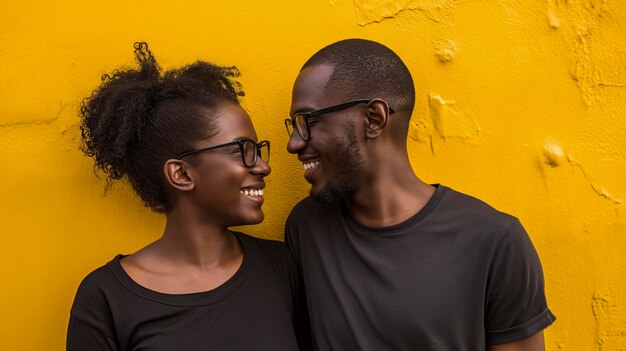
[67,43,308,351]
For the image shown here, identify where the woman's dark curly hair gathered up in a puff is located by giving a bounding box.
[80,42,244,212]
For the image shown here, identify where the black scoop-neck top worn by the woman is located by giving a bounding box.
[67,233,306,351]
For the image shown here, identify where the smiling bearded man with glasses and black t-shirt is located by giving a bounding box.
[285,39,555,351]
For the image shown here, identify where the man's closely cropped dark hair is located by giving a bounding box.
[302,39,415,122]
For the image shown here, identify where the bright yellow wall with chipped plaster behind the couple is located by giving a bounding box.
[0,0,626,350]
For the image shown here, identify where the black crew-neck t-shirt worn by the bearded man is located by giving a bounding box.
[285,186,555,351]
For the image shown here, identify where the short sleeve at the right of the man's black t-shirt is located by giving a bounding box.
[485,219,556,344]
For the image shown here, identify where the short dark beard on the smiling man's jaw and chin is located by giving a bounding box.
[310,123,363,203]
